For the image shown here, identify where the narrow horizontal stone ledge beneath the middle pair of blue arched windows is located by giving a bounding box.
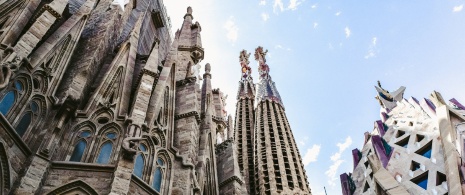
[51,161,115,173]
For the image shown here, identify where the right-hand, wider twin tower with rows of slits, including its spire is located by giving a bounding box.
[253,47,311,194]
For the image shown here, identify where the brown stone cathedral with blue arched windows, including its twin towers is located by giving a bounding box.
[0,0,311,195]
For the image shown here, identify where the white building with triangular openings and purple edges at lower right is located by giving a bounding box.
[340,83,465,195]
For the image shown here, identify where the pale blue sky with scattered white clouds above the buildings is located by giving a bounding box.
[164,0,465,195]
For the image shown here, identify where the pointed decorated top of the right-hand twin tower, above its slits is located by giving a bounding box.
[255,46,284,107]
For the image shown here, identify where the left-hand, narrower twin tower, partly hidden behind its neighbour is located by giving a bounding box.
[235,50,255,194]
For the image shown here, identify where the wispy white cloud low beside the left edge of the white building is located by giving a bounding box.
[325,136,352,186]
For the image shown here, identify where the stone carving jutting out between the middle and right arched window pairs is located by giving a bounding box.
[122,124,142,160]
